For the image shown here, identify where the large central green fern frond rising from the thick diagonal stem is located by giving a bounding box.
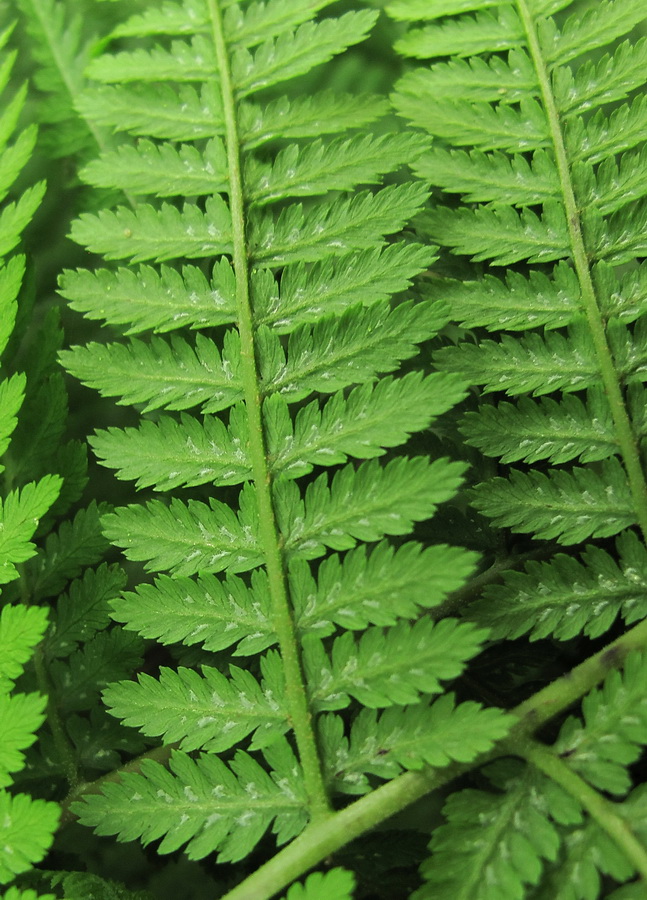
[61,0,508,897]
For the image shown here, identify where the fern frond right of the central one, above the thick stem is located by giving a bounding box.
[390,0,647,638]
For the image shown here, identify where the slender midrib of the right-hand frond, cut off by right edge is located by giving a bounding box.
[517,0,647,542]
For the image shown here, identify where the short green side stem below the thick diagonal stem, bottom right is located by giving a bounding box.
[513,740,647,884]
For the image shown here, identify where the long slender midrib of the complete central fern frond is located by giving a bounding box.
[208,0,330,821]
